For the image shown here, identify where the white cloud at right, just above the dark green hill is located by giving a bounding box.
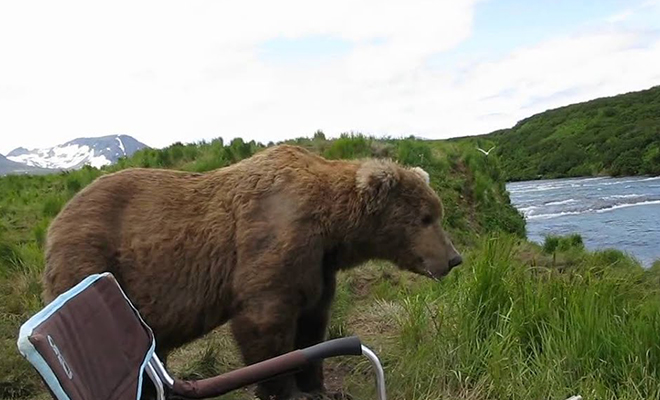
[452,31,660,125]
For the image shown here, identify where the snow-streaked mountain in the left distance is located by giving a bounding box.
[7,135,147,170]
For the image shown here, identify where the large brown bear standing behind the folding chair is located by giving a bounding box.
[43,145,461,399]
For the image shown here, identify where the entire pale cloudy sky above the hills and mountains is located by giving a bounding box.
[0,0,660,154]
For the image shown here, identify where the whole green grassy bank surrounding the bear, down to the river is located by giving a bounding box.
[0,132,660,399]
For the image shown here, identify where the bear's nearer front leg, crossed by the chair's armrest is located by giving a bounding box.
[231,296,298,400]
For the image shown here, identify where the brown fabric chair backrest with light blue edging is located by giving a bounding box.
[19,274,155,400]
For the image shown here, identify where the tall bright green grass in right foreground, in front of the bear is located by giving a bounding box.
[336,236,660,399]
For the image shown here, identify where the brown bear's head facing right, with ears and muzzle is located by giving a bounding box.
[356,159,462,279]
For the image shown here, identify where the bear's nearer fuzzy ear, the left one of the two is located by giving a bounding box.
[355,159,400,213]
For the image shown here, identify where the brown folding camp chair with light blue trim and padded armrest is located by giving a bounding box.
[17,273,386,400]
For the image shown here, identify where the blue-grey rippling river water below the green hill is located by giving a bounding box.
[507,177,660,267]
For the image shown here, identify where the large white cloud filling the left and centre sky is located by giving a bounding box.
[0,0,473,152]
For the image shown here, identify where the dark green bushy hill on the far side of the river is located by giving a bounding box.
[459,86,660,181]
